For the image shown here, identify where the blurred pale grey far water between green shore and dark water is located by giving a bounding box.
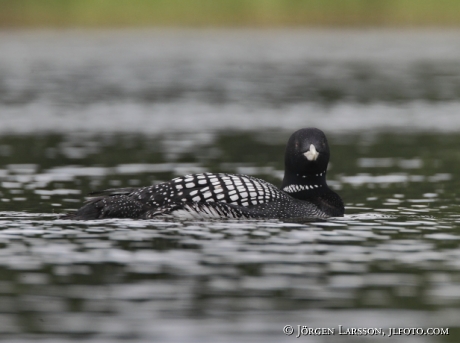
[0,30,460,134]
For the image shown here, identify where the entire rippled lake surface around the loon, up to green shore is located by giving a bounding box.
[0,30,460,343]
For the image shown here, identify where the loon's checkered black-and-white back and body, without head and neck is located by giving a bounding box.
[62,173,330,220]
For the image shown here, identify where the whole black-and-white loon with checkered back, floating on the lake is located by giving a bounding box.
[62,128,344,220]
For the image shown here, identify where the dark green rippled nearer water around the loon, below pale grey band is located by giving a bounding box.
[0,131,460,342]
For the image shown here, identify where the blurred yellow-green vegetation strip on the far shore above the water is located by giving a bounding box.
[0,0,460,28]
